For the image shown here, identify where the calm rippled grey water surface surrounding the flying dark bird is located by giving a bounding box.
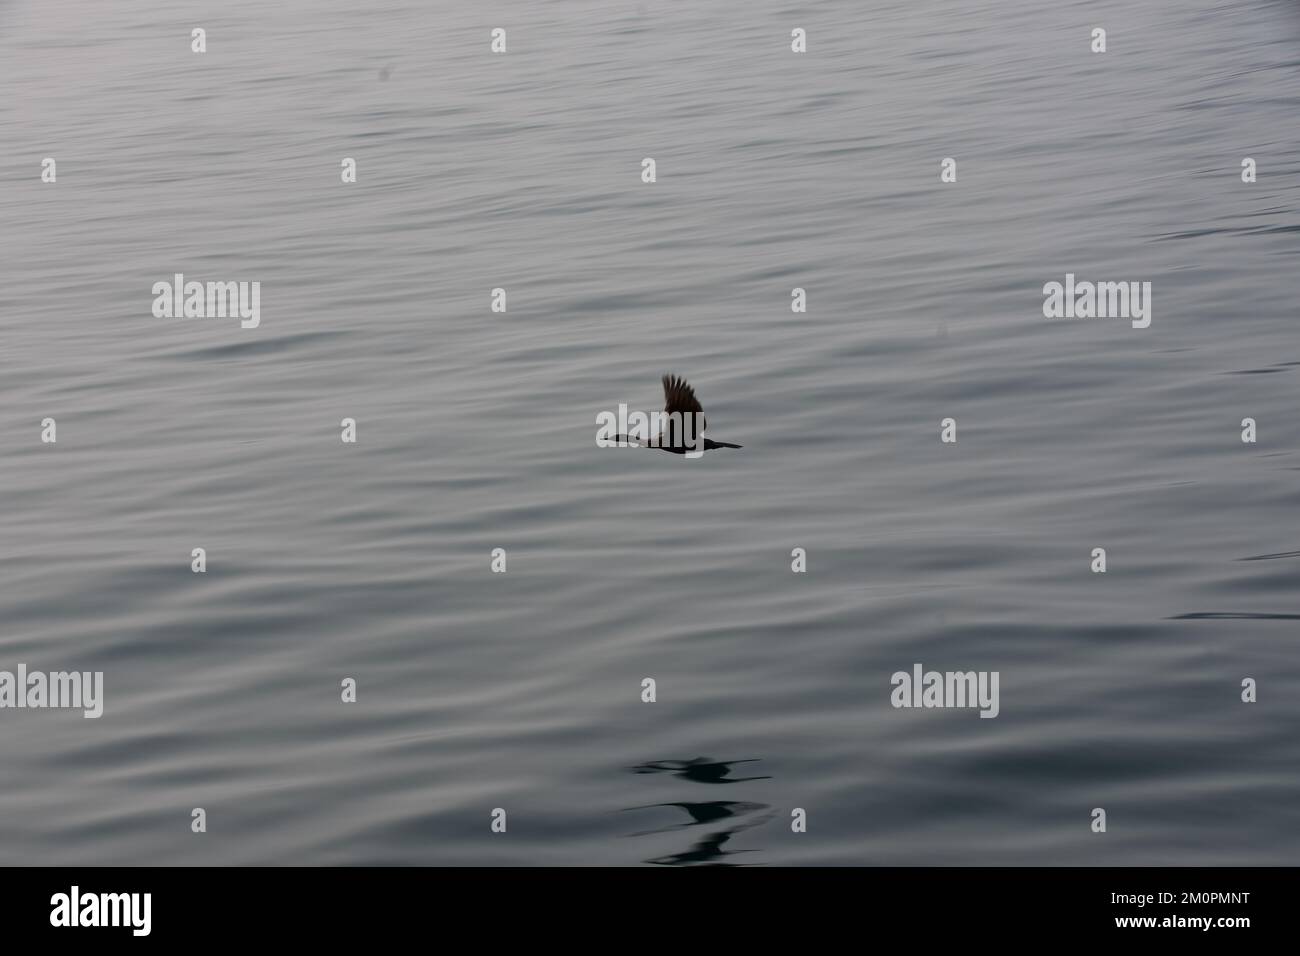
[0,0,1300,865]
